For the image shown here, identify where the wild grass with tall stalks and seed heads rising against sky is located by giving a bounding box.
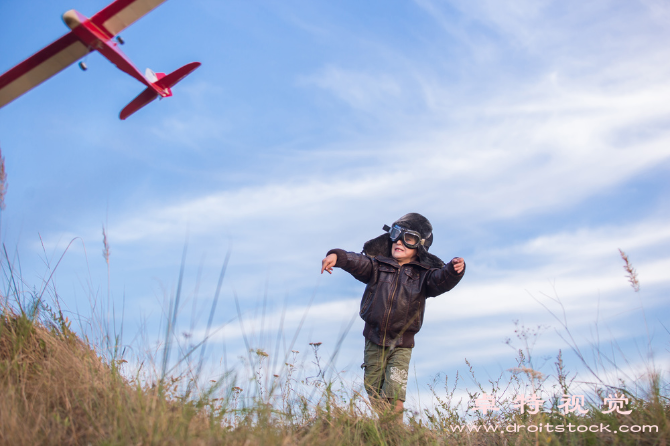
[0,244,670,446]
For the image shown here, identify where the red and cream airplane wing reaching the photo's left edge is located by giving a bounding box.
[0,32,92,107]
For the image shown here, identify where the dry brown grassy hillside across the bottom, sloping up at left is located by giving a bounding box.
[0,302,670,445]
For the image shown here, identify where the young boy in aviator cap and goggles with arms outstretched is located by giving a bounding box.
[321,213,465,413]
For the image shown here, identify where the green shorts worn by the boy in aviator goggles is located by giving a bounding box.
[361,339,412,401]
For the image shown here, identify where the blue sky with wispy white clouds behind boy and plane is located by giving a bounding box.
[0,0,670,410]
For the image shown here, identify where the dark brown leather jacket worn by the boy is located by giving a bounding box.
[328,249,465,347]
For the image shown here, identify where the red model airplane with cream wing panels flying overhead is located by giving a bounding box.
[0,0,200,119]
